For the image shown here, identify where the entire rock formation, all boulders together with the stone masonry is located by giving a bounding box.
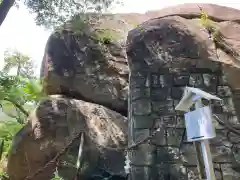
[5,4,240,180]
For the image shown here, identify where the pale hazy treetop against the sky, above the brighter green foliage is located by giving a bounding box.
[3,50,35,78]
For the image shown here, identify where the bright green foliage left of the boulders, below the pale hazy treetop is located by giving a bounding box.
[0,72,46,165]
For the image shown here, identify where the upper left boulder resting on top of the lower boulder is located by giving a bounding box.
[41,14,154,114]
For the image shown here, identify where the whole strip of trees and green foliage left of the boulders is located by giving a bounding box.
[0,51,47,179]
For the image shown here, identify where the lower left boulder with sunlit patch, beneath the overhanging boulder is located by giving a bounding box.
[8,96,127,180]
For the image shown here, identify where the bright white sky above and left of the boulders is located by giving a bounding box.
[0,0,240,74]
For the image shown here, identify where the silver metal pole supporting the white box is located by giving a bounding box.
[195,98,216,180]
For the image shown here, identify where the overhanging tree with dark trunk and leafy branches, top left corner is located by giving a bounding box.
[0,0,118,28]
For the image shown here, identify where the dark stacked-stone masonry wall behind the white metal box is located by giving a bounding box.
[129,67,240,180]
